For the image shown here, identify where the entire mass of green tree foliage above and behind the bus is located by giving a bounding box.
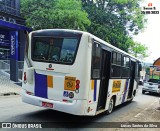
[20,0,147,57]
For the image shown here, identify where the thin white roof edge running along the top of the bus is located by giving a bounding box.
[31,29,140,61]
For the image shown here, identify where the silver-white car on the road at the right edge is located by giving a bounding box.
[142,79,160,94]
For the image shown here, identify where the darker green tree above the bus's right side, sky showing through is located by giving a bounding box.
[82,0,145,52]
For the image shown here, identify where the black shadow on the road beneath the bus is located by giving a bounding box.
[4,101,137,128]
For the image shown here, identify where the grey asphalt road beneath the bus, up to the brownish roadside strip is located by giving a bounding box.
[0,87,159,127]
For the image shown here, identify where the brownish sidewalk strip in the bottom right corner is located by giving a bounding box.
[110,95,160,131]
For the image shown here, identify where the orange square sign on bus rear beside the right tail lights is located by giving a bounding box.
[64,76,76,91]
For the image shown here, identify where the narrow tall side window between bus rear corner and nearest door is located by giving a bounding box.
[91,42,101,79]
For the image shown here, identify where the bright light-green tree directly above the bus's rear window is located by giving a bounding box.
[21,0,91,30]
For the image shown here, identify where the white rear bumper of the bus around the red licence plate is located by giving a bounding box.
[21,89,87,115]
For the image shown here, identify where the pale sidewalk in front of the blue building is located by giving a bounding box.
[0,71,21,96]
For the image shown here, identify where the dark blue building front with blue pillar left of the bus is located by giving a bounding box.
[0,0,31,82]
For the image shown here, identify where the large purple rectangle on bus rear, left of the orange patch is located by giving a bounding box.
[34,72,48,98]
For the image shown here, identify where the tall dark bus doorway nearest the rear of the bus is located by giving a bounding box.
[97,50,111,111]
